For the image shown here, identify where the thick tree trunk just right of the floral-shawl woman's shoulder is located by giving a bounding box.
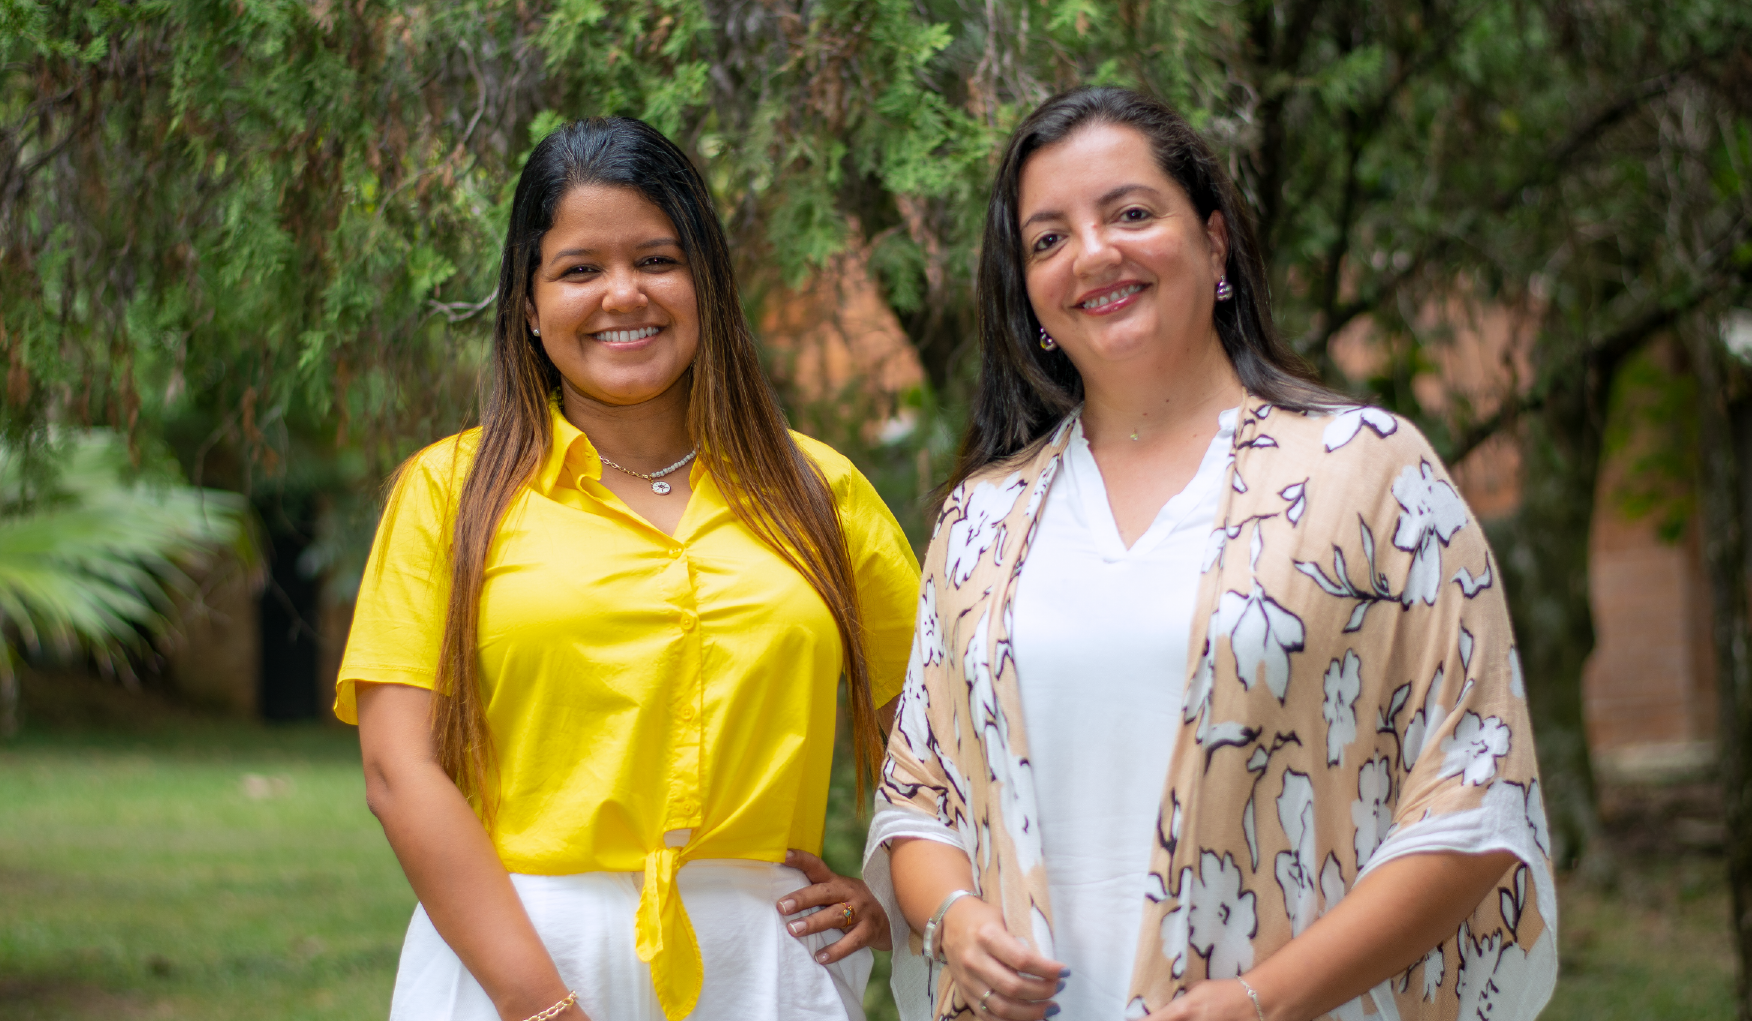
[1491,378,1612,879]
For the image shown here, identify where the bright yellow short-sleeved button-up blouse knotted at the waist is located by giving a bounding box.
[335,410,918,1017]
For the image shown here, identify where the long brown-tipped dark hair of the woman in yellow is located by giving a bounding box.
[431,117,881,821]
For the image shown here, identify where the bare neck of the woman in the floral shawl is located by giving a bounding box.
[1077,329,1247,445]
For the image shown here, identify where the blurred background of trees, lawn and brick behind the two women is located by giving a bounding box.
[0,0,1752,1019]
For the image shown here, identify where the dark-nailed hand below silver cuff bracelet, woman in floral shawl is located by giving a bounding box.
[939,897,1069,1021]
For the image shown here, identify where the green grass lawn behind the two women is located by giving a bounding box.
[0,693,1733,1021]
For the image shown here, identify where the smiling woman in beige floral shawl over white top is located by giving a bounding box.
[865,89,1556,1021]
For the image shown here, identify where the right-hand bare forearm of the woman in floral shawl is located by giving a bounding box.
[1246,851,1514,1021]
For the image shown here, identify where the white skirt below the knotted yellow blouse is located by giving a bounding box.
[389,858,874,1021]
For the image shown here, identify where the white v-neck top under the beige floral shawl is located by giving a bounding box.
[1011,410,1235,1019]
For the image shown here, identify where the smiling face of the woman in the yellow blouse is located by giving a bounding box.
[529,184,699,406]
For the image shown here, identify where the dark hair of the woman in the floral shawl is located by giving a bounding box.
[944,86,1351,489]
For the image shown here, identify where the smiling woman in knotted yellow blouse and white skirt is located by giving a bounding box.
[336,119,918,1021]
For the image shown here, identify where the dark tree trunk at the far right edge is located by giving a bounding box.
[1687,329,1752,1021]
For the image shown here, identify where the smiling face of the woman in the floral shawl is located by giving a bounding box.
[1016,123,1228,375]
